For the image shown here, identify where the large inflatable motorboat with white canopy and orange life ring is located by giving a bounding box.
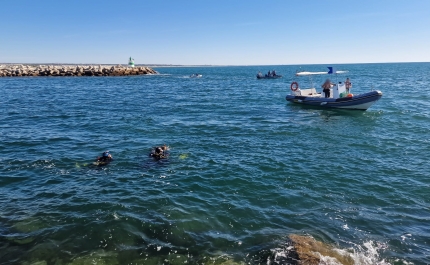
[285,67,382,110]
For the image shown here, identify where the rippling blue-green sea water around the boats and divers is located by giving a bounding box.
[0,63,430,265]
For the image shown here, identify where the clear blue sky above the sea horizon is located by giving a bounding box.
[0,0,430,65]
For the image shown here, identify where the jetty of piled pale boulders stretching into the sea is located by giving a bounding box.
[0,64,157,77]
